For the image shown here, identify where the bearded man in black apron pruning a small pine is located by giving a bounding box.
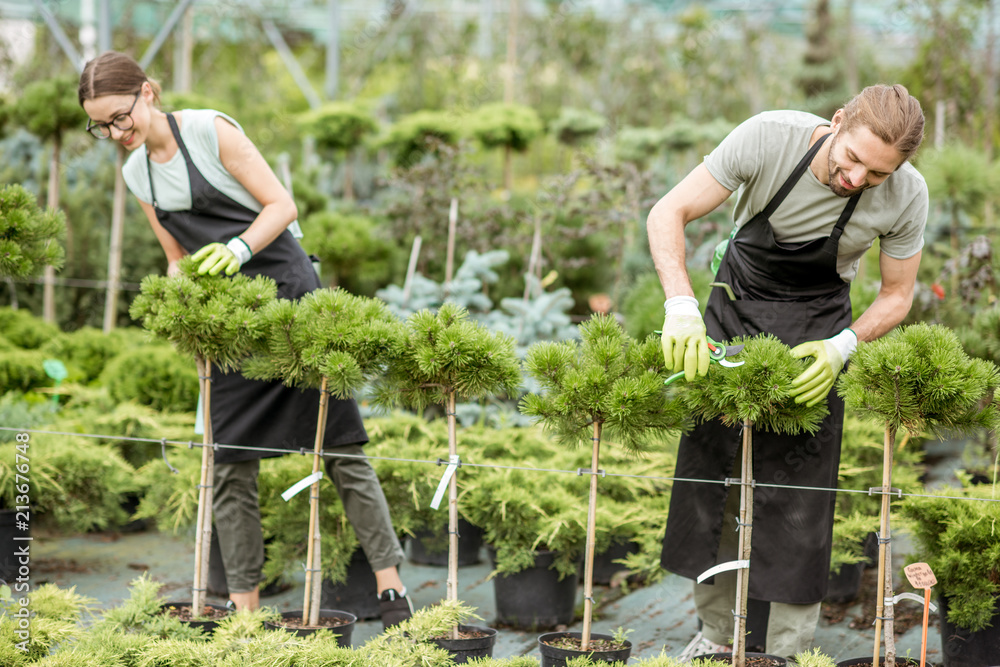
[647,85,928,659]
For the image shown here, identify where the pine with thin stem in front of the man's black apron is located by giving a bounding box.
[680,334,827,667]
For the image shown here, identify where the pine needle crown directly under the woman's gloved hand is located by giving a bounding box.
[129,256,277,370]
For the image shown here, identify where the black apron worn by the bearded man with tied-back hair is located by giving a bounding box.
[661,134,861,604]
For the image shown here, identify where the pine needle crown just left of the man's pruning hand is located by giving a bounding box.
[520,315,685,451]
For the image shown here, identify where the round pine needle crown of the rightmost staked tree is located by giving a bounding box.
[837,324,1000,436]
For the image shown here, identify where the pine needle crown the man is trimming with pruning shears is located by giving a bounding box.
[677,334,828,435]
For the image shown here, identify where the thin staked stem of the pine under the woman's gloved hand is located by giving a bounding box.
[191,357,215,617]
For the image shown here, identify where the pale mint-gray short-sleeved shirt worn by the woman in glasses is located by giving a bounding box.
[122,109,263,212]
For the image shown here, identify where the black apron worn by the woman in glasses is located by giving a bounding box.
[146,114,368,463]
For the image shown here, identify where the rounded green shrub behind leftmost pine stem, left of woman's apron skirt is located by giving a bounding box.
[101,344,198,412]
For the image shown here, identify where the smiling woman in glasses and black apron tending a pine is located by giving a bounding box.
[79,51,412,627]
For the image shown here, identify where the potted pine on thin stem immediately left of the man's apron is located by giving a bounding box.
[521,315,684,667]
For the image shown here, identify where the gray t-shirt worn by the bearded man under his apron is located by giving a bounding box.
[705,111,928,282]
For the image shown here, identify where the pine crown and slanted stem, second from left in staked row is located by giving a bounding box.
[243,289,399,628]
